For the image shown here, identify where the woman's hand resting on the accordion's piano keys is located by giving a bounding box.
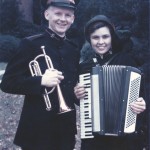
[74,83,86,99]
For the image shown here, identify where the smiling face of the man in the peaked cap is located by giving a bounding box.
[45,6,74,37]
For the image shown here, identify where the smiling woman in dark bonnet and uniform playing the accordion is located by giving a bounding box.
[74,15,146,150]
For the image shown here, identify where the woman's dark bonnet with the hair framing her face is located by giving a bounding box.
[85,15,121,52]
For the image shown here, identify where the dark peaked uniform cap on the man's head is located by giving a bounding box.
[41,0,79,10]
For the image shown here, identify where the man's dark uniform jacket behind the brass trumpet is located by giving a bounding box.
[1,29,79,147]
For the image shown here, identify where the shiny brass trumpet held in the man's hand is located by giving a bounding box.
[29,46,72,114]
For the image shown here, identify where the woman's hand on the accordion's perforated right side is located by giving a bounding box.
[130,97,146,114]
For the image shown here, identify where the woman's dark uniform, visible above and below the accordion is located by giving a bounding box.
[80,52,144,150]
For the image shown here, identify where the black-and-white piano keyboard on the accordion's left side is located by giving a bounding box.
[80,73,93,139]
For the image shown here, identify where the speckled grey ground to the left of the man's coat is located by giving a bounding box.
[0,91,23,150]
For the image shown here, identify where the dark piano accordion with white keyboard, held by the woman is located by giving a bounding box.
[79,65,141,139]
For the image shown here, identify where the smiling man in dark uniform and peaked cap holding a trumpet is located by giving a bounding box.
[1,0,79,150]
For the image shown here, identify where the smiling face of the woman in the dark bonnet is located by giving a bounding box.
[90,27,111,55]
